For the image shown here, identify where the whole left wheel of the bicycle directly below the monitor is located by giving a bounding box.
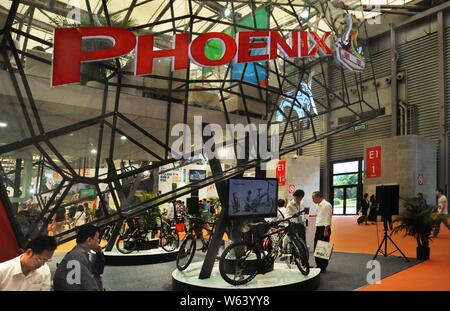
[219,241,261,285]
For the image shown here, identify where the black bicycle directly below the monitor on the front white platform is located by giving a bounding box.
[219,211,310,285]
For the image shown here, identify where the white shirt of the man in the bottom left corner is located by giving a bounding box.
[0,256,51,291]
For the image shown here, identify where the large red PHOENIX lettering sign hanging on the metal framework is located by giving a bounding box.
[52,27,333,86]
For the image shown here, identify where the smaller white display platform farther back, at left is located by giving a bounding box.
[104,246,178,266]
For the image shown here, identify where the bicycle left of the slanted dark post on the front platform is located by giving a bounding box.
[177,215,215,271]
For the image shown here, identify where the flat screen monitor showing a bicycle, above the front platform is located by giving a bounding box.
[228,178,278,217]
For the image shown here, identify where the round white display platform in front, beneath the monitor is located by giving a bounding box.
[172,261,320,291]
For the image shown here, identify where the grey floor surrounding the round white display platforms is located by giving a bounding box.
[50,252,418,291]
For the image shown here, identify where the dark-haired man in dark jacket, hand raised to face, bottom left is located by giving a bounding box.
[53,224,105,291]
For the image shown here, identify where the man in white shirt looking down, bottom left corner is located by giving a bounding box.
[0,236,56,291]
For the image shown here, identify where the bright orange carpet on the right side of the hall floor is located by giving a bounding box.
[332,216,450,291]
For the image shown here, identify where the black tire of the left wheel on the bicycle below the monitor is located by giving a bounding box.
[219,241,261,285]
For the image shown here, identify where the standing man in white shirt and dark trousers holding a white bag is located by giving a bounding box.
[312,191,333,272]
